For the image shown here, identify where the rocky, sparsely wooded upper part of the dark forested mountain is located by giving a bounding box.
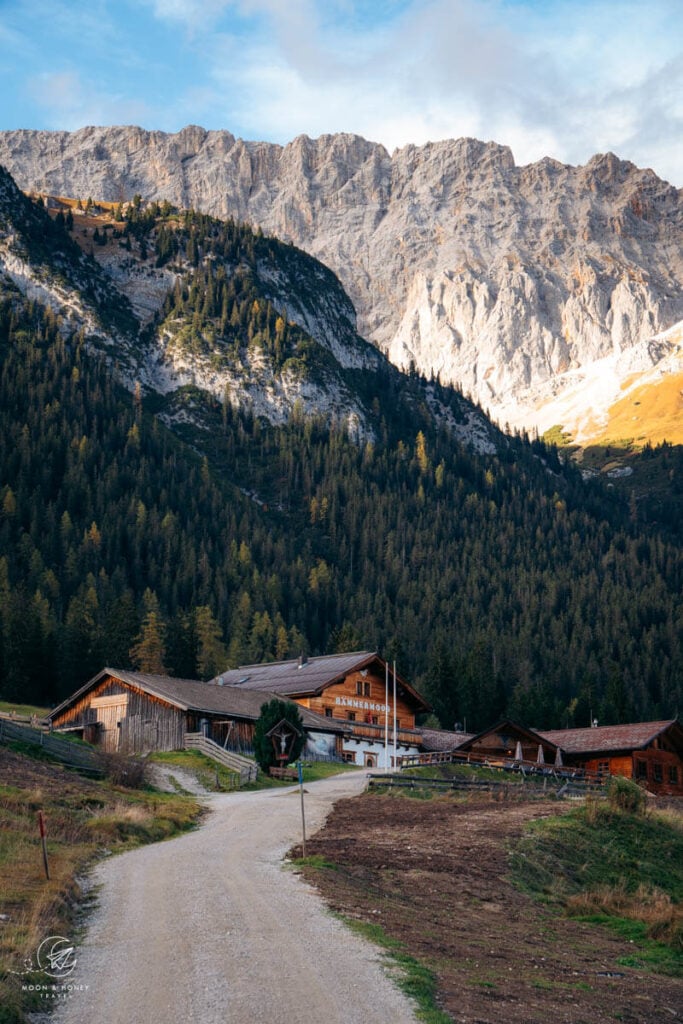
[0,169,502,451]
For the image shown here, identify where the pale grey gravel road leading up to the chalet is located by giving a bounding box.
[53,772,416,1024]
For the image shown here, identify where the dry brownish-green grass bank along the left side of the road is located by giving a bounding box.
[0,748,201,1024]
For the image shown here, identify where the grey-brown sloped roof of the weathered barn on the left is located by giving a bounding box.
[47,668,344,732]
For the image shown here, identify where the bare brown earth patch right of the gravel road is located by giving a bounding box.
[304,794,683,1024]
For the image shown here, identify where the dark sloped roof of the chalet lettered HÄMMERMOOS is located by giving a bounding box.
[212,650,429,711]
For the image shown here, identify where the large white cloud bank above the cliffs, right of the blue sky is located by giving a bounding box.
[196,0,683,184]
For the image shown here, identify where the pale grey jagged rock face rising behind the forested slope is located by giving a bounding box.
[0,127,683,424]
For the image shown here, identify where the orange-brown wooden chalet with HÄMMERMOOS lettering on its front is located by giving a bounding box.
[213,651,431,767]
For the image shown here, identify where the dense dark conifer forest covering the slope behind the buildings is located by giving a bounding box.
[0,184,683,730]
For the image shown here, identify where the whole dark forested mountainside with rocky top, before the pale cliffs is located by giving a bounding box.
[0,144,683,728]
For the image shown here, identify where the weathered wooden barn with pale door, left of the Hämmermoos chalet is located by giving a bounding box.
[48,669,344,756]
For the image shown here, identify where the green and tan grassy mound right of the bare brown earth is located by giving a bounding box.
[510,798,683,977]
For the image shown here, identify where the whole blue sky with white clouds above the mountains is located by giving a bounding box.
[0,0,683,187]
